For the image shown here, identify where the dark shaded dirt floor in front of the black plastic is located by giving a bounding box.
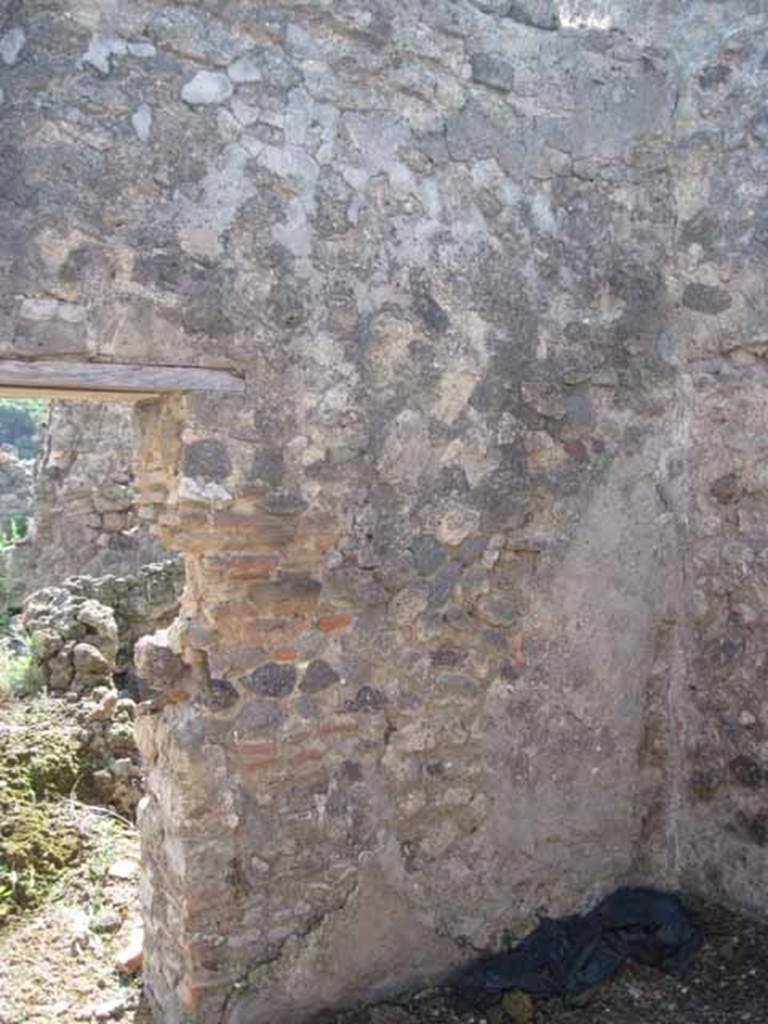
[327,904,768,1024]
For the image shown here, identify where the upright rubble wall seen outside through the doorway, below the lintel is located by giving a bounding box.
[11,401,168,595]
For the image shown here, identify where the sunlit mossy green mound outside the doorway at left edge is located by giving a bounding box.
[0,697,83,924]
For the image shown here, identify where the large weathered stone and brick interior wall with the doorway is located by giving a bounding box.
[0,0,768,1024]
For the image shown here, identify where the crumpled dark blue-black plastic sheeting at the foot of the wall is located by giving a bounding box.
[455,889,702,997]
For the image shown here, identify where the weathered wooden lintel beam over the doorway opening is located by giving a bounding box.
[0,358,246,393]
